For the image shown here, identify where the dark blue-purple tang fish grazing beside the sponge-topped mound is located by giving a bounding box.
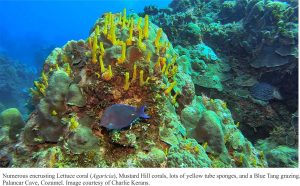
[100,104,150,130]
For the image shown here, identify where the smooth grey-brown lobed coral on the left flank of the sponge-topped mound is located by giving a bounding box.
[24,70,77,145]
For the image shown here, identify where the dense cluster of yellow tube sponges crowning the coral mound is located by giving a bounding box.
[87,9,179,102]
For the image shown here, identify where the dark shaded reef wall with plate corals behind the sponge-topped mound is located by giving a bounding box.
[141,0,298,167]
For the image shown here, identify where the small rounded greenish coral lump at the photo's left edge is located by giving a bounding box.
[0,108,25,141]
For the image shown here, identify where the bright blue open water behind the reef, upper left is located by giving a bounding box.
[0,0,171,68]
